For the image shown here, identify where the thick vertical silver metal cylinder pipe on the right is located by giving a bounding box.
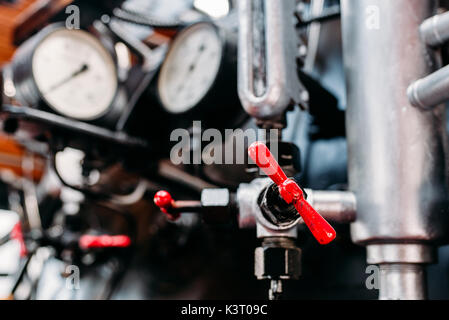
[342,0,448,299]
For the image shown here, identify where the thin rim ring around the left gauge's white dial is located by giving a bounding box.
[30,24,119,121]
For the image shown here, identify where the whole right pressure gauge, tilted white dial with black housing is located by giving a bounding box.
[157,22,240,126]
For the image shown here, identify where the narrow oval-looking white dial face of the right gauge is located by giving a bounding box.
[158,23,223,113]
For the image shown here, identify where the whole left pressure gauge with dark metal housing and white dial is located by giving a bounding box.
[12,25,118,121]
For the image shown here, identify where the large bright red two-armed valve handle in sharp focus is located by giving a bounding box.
[248,142,337,244]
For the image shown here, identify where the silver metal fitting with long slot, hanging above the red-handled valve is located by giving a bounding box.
[234,0,309,119]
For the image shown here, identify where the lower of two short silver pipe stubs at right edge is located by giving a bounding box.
[407,66,449,109]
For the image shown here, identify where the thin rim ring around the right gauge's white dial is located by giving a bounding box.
[156,21,226,115]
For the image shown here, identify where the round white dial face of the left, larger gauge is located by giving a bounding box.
[32,29,118,120]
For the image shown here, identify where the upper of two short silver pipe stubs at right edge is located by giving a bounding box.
[420,12,449,47]
